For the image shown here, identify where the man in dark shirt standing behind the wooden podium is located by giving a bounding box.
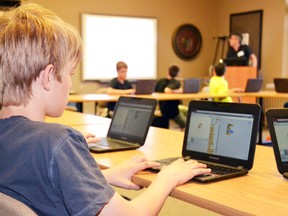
[226,33,257,67]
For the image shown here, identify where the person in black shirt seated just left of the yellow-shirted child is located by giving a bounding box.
[155,65,186,130]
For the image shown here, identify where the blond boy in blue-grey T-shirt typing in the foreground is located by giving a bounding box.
[0,4,210,215]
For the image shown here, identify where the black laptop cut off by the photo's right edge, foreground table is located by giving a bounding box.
[266,108,288,179]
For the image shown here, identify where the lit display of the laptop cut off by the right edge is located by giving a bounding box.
[273,118,288,162]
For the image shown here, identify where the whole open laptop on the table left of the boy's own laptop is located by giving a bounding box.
[88,96,157,153]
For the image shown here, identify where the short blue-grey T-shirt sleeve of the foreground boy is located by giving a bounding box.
[50,130,114,215]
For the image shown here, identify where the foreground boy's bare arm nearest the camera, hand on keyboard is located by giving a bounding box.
[99,159,211,216]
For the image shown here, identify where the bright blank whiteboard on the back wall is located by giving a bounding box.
[81,14,157,81]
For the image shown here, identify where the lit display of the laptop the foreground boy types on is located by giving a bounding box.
[186,110,253,160]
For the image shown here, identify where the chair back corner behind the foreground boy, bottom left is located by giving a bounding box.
[0,192,37,216]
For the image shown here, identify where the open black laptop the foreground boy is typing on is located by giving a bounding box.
[148,101,261,183]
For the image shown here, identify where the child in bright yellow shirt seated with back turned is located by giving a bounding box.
[209,62,243,102]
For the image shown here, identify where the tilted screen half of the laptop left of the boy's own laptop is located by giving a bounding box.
[107,97,156,144]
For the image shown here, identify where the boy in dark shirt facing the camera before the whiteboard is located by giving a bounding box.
[107,61,135,117]
